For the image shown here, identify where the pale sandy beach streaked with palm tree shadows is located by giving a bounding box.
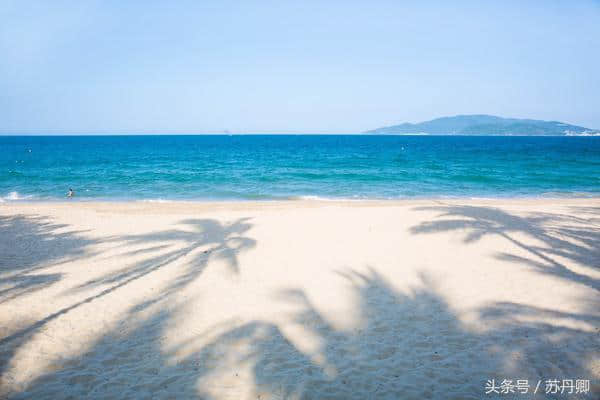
[0,199,600,399]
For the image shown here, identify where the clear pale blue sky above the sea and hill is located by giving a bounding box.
[0,0,600,133]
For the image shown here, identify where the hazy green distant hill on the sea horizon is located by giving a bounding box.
[365,115,600,136]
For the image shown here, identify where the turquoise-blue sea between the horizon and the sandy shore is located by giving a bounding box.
[0,135,600,202]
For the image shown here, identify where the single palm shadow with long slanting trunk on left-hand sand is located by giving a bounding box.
[0,218,256,386]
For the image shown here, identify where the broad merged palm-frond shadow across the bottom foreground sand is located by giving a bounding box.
[9,269,599,399]
